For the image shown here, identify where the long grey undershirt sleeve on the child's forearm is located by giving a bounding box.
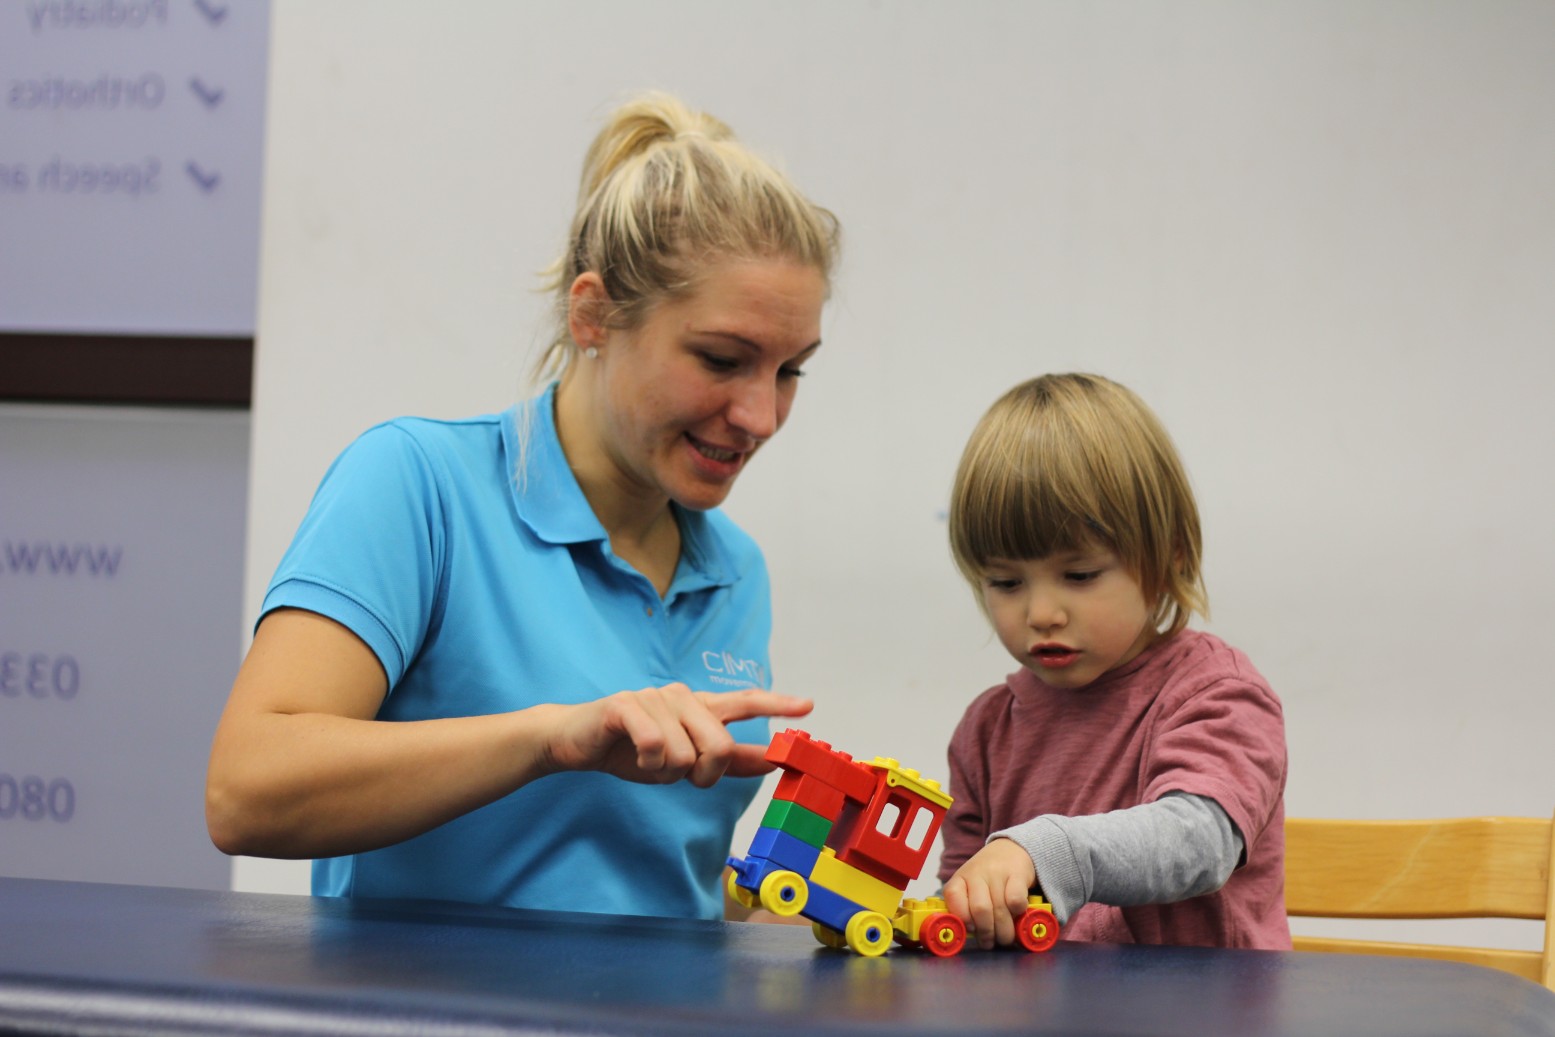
[987,793,1242,924]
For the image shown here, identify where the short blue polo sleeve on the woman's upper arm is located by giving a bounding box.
[260,423,446,689]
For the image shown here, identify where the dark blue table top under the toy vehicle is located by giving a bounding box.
[0,878,1555,1037]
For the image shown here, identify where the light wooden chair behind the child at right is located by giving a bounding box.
[1284,818,1555,990]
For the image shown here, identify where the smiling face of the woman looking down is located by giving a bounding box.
[580,258,827,510]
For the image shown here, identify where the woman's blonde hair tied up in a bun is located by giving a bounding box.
[535,92,838,381]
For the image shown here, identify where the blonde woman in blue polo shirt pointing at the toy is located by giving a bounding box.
[207,95,837,917]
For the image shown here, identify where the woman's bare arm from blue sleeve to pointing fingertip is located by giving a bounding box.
[205,609,810,858]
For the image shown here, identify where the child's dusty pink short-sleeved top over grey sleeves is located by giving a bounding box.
[939,630,1291,948]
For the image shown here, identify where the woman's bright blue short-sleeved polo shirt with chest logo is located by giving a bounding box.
[263,386,771,919]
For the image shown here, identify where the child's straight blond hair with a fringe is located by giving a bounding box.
[950,375,1208,636]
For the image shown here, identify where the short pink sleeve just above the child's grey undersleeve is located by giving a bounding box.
[1143,675,1286,854]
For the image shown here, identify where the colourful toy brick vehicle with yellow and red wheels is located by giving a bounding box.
[728,728,1059,958]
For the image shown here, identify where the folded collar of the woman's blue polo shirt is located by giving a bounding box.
[502,382,739,597]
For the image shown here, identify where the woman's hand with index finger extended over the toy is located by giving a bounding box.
[536,684,812,788]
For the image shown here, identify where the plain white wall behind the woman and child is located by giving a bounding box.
[238,0,1555,951]
